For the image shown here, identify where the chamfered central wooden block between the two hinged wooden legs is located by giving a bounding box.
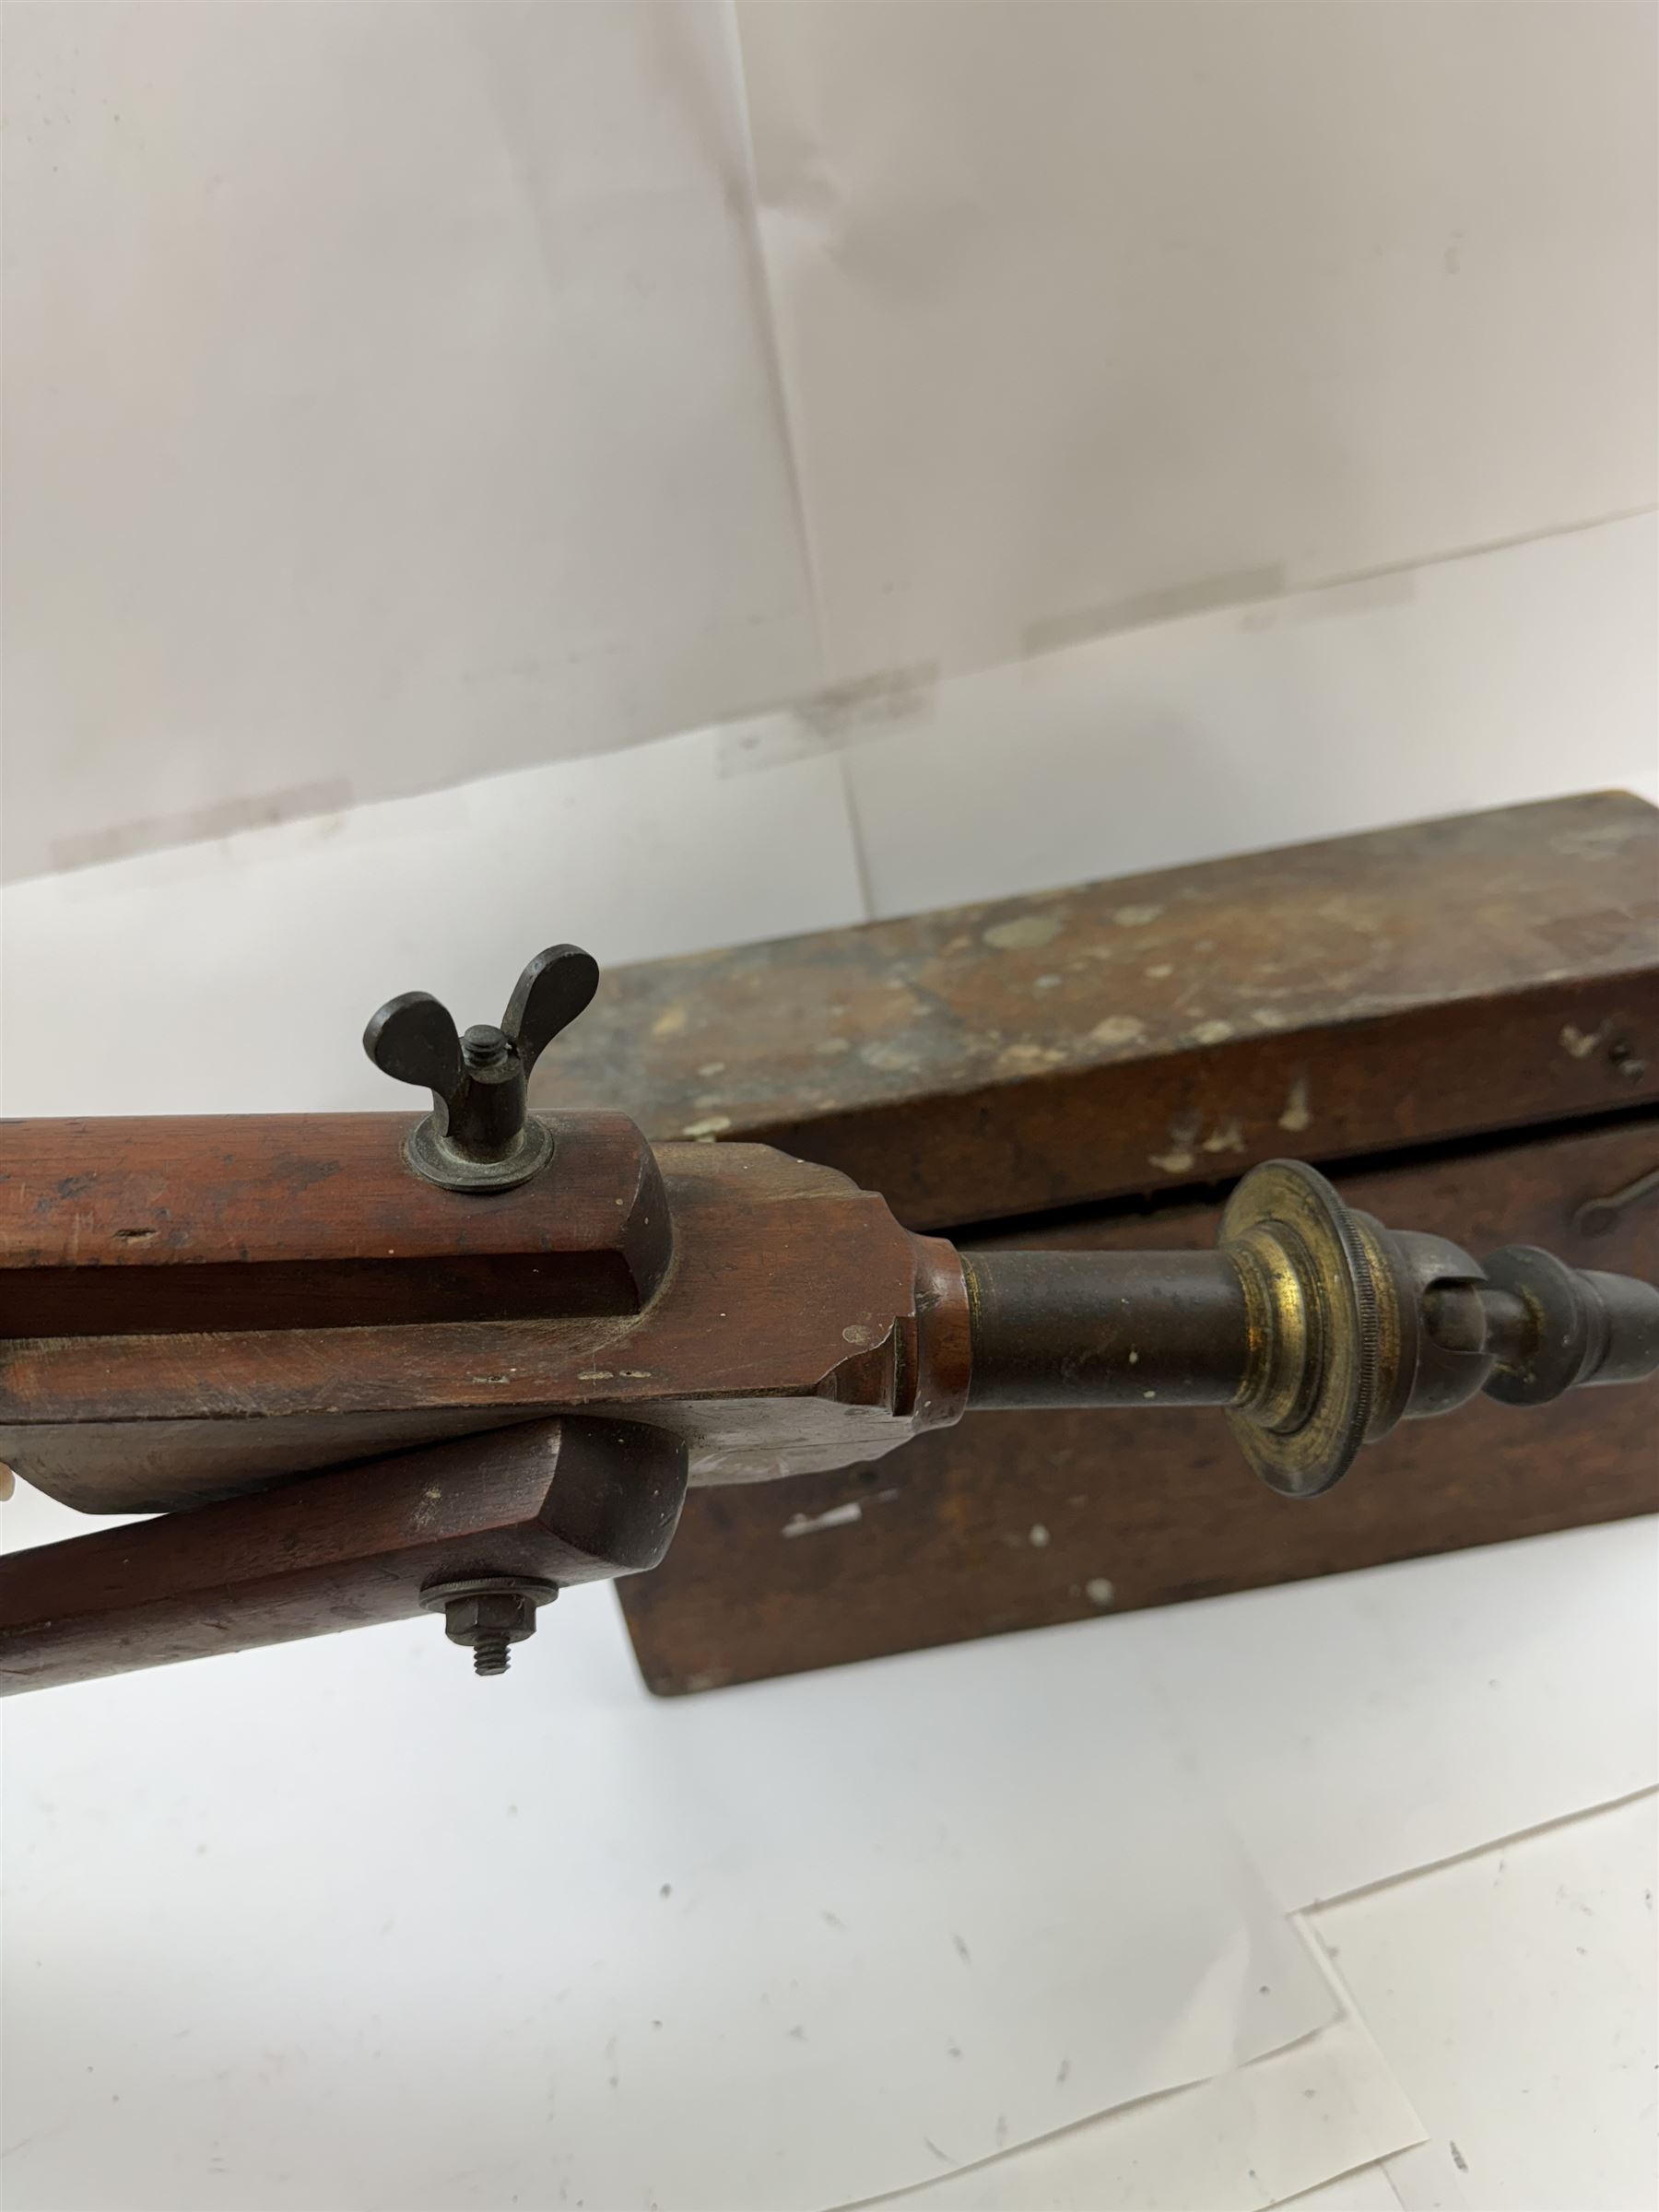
[0,1117,967,1513]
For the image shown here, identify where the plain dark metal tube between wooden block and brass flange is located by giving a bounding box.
[962,1252,1250,1406]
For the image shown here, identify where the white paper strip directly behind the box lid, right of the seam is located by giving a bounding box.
[844,512,1659,920]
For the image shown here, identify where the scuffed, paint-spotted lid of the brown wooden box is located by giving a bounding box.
[533,792,1659,1228]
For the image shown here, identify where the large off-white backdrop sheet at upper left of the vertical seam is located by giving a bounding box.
[5,5,823,880]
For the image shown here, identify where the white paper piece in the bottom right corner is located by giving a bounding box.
[1307,1792,1659,2212]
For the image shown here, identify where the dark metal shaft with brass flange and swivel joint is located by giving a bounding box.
[962,1159,1659,1498]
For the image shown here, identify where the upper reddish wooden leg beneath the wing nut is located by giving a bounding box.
[0,1112,673,1338]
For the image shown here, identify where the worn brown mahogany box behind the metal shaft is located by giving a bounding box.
[535,792,1659,1692]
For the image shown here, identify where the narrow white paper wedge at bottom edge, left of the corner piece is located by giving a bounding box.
[891,1964,1422,2212]
